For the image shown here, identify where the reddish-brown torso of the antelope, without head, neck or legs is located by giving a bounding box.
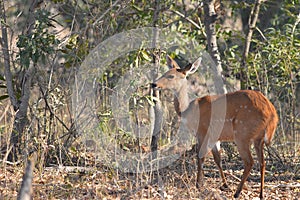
[182,90,278,144]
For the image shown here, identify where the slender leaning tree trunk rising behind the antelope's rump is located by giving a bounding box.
[240,0,261,89]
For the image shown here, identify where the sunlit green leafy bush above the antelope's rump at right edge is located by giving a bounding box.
[249,24,300,95]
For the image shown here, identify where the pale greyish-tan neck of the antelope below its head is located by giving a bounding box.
[174,81,190,116]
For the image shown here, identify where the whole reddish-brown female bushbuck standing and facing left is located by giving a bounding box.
[152,56,278,199]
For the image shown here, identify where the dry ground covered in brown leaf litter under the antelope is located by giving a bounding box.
[0,146,300,200]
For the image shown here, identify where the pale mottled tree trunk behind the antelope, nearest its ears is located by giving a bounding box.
[204,0,227,94]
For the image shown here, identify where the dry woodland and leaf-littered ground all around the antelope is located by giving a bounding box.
[0,0,300,199]
